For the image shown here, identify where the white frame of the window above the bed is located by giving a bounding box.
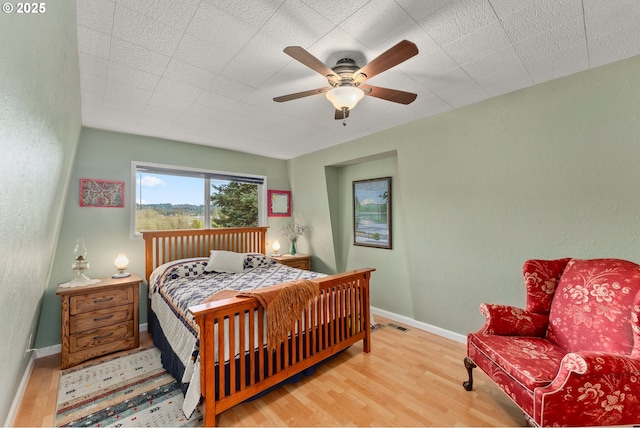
[129,161,267,238]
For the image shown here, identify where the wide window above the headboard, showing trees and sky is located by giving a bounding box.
[131,162,266,236]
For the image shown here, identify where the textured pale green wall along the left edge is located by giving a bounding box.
[0,0,81,423]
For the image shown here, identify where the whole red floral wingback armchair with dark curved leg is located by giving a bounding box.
[463,259,640,426]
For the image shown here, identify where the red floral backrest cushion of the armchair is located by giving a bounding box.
[547,259,640,355]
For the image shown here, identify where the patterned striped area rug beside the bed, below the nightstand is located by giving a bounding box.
[54,348,202,427]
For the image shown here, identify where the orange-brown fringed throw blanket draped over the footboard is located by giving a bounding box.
[205,279,320,350]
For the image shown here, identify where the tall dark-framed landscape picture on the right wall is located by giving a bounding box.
[353,177,391,249]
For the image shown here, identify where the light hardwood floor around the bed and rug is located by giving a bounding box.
[15,317,527,426]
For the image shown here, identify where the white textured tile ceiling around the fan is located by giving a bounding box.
[77,0,640,159]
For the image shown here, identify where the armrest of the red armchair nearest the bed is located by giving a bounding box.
[479,303,549,337]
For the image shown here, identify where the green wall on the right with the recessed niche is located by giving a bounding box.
[289,52,640,334]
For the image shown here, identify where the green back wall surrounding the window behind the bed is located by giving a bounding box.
[37,128,290,348]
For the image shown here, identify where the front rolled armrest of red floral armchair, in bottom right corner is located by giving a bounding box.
[534,352,640,426]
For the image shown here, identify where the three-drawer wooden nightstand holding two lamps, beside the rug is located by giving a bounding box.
[56,274,142,369]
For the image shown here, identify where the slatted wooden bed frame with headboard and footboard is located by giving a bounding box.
[142,227,375,426]
